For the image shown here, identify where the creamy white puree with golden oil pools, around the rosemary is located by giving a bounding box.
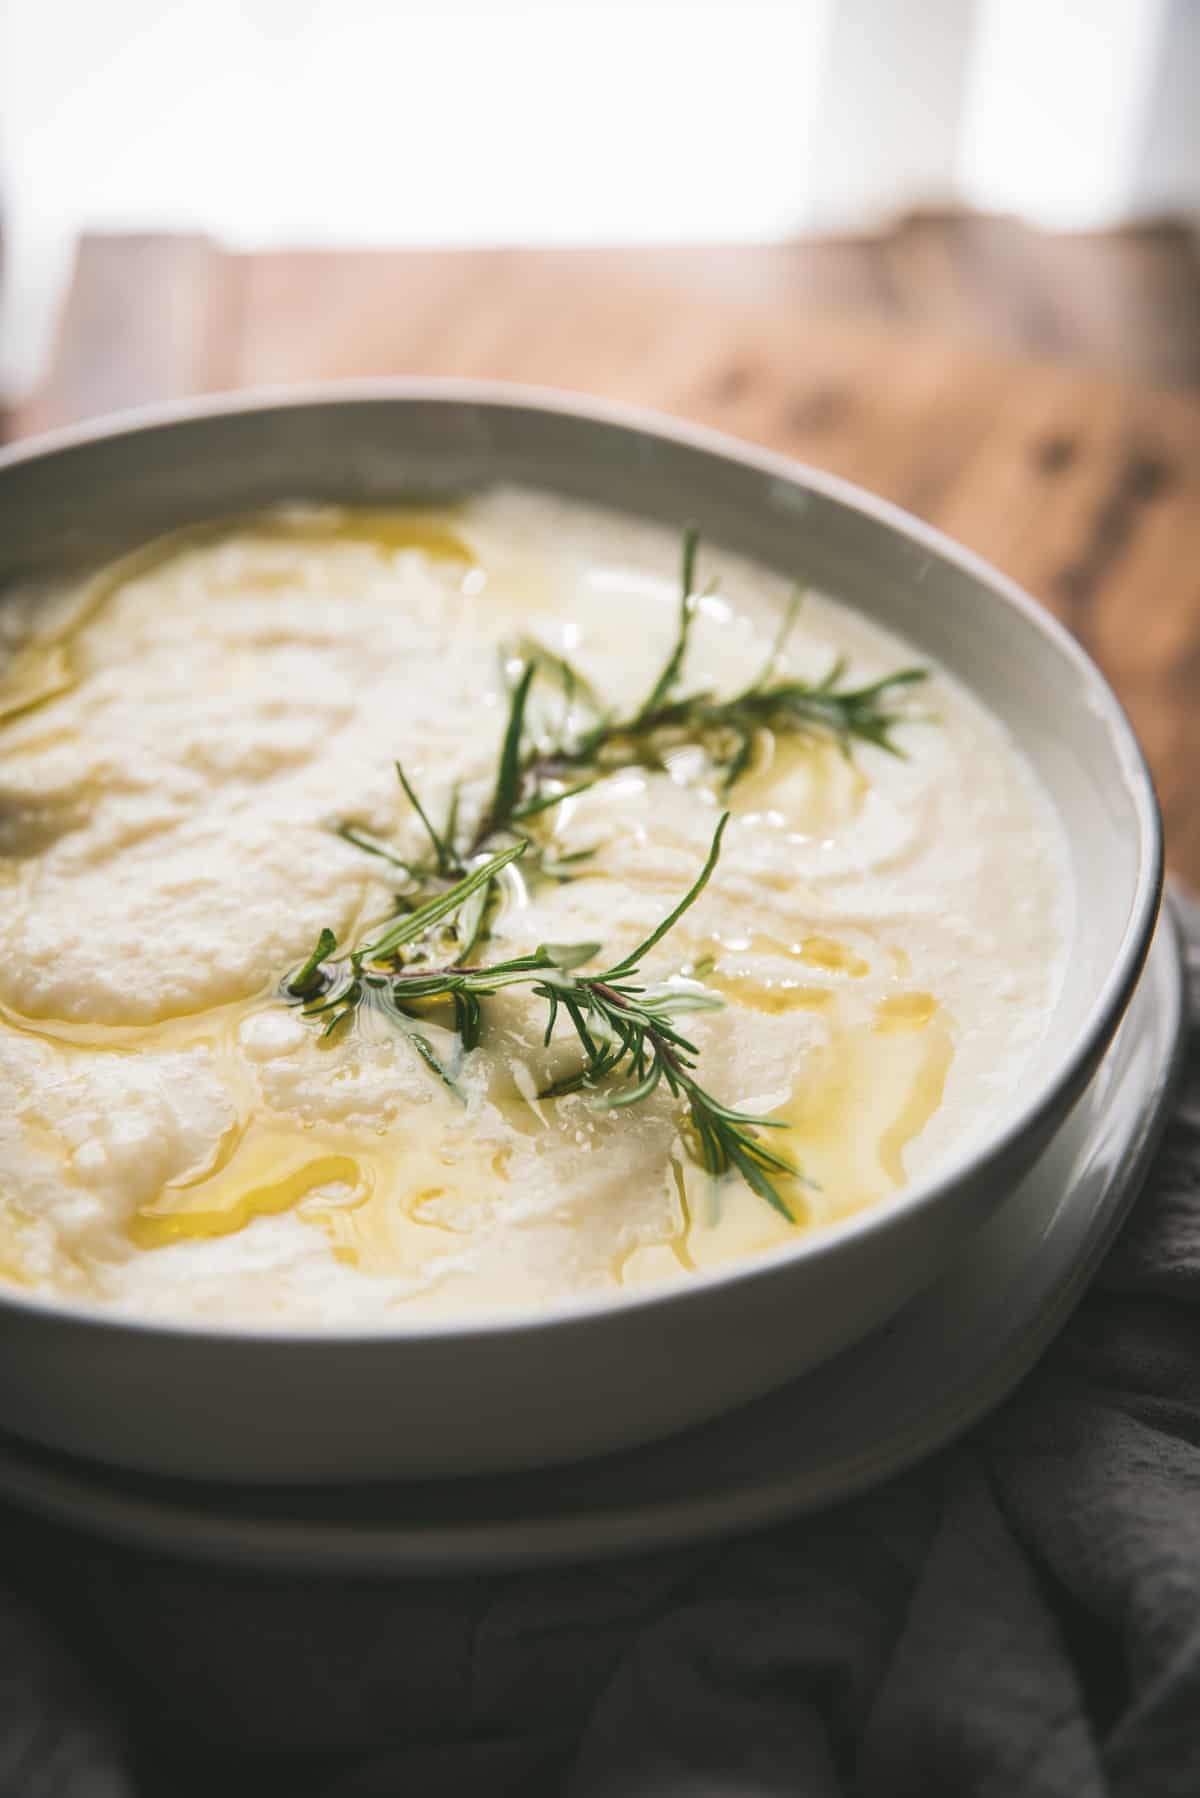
[0,491,1070,1323]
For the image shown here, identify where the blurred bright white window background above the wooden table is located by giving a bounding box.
[0,0,1200,392]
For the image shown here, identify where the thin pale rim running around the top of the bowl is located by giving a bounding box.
[0,376,1164,1350]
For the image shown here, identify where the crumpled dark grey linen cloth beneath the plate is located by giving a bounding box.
[0,906,1200,1798]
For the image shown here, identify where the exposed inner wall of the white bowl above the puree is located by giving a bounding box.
[0,383,1160,1179]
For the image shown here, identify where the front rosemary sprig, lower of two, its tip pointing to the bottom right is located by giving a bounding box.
[284,813,799,1219]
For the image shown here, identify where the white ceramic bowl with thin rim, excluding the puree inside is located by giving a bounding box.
[0,381,1162,1483]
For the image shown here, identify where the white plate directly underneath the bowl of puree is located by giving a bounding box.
[0,910,1186,1577]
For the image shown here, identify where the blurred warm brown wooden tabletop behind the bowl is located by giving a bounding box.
[16,237,1200,886]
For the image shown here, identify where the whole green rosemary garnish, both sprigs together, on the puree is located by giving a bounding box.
[282,527,927,1217]
